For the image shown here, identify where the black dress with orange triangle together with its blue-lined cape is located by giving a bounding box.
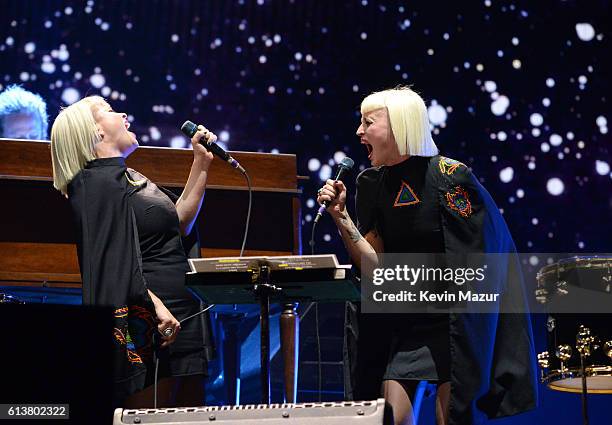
[344,156,537,425]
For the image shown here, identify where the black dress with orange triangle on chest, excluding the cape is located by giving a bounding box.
[356,156,450,380]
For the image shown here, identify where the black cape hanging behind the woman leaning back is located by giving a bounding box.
[68,158,156,404]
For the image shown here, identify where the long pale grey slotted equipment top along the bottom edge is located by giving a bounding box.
[113,398,393,425]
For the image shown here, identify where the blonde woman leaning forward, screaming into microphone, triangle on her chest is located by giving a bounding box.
[317,87,537,425]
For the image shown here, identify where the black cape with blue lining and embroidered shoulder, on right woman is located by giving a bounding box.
[344,156,537,425]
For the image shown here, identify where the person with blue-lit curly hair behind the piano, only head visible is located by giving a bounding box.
[0,85,48,140]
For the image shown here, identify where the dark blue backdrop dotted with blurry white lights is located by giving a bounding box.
[0,0,612,418]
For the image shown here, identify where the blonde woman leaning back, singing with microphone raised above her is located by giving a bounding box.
[51,96,216,408]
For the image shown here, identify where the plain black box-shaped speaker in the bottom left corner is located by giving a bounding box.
[0,303,113,425]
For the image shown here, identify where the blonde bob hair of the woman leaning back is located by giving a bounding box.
[51,96,106,195]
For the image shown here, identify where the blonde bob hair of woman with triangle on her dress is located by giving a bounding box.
[361,87,438,156]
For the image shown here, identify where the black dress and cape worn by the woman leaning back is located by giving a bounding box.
[68,157,207,406]
